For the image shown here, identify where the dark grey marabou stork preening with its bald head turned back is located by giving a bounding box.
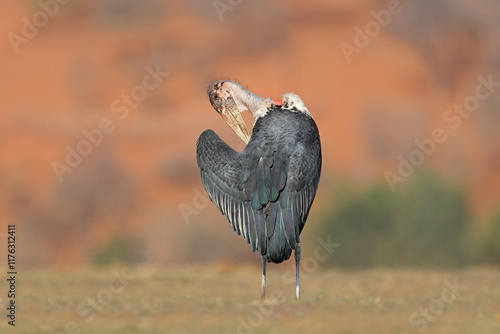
[196,80,321,300]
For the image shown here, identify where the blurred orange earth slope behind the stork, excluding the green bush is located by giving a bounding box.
[0,0,500,267]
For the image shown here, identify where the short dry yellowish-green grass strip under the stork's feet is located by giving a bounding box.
[5,261,500,334]
